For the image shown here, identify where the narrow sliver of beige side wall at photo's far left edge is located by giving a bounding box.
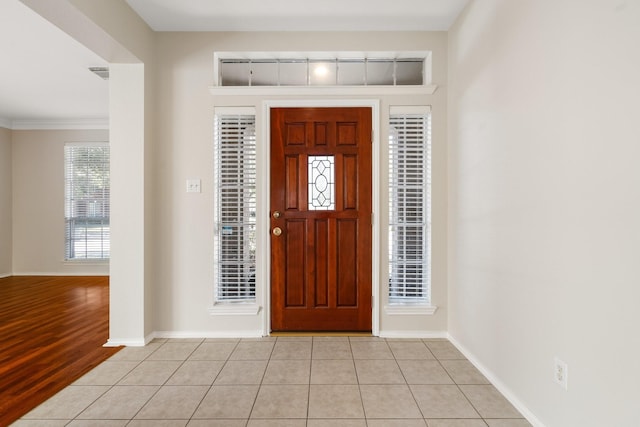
[0,127,12,277]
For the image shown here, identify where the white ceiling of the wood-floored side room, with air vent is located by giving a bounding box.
[0,0,109,128]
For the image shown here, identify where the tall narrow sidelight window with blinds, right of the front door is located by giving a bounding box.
[389,107,431,304]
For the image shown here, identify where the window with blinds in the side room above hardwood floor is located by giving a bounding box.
[64,143,110,260]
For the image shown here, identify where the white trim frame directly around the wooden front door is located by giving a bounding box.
[256,98,381,336]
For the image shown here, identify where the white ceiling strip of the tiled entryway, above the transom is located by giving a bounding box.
[127,0,468,31]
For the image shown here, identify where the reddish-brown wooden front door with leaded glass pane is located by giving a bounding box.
[270,107,372,331]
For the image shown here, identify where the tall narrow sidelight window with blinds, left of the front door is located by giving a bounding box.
[214,113,256,302]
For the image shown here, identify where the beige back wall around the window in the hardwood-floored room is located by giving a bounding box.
[12,130,109,275]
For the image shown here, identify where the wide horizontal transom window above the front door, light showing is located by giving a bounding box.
[215,51,431,87]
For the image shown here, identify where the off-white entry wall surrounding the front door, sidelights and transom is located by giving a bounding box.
[154,32,447,335]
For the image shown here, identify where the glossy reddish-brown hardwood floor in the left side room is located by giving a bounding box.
[0,276,120,426]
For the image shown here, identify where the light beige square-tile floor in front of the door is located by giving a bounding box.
[14,337,530,427]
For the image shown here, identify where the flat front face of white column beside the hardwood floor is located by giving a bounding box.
[109,64,147,345]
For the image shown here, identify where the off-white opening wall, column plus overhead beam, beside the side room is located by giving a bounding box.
[39,0,156,345]
